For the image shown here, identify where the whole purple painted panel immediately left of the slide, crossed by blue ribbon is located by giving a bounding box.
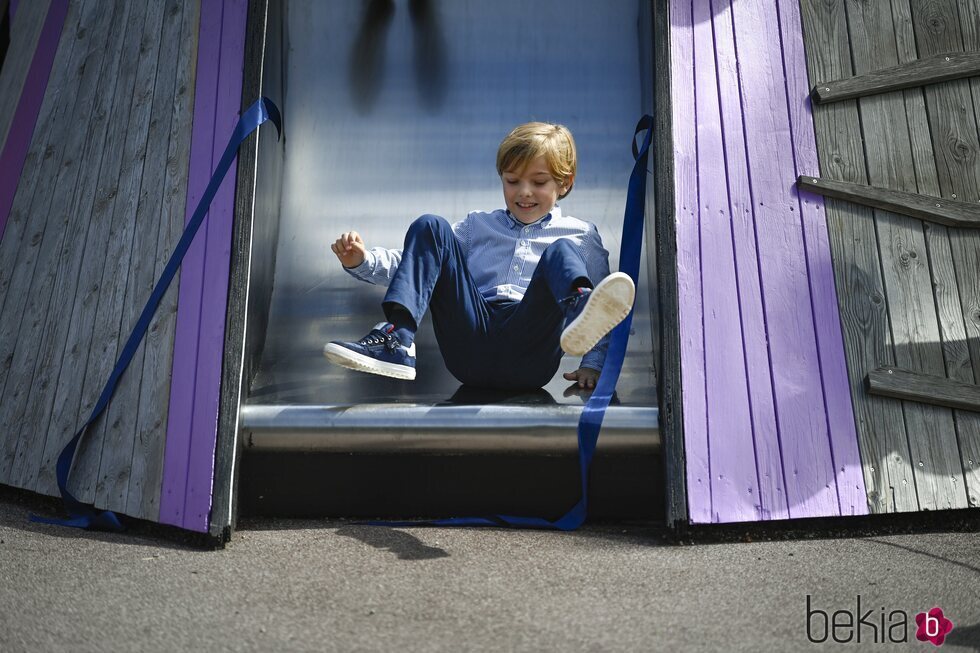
[160,0,247,532]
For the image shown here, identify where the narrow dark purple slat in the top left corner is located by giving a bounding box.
[0,0,68,240]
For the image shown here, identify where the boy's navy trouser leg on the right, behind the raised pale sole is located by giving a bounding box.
[494,239,592,388]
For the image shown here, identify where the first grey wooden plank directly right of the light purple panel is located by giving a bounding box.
[801,0,918,512]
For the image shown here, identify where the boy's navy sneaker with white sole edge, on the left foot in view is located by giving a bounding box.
[323,322,415,381]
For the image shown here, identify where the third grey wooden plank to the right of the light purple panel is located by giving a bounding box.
[908,0,980,505]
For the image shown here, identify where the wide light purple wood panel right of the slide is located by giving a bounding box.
[671,0,866,523]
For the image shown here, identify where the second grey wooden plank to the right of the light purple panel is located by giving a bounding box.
[848,3,967,510]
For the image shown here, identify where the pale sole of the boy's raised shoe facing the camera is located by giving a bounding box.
[561,272,636,356]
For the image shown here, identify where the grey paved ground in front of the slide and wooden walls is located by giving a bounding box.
[0,498,980,653]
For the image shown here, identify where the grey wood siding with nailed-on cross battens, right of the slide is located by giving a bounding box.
[802,0,980,512]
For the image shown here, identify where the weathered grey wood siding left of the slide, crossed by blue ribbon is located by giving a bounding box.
[0,0,199,520]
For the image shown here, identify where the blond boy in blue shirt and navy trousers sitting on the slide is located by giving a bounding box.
[323,122,635,389]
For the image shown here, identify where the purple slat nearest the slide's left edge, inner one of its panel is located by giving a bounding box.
[183,0,248,530]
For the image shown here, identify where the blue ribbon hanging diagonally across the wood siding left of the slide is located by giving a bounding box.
[31,97,282,531]
